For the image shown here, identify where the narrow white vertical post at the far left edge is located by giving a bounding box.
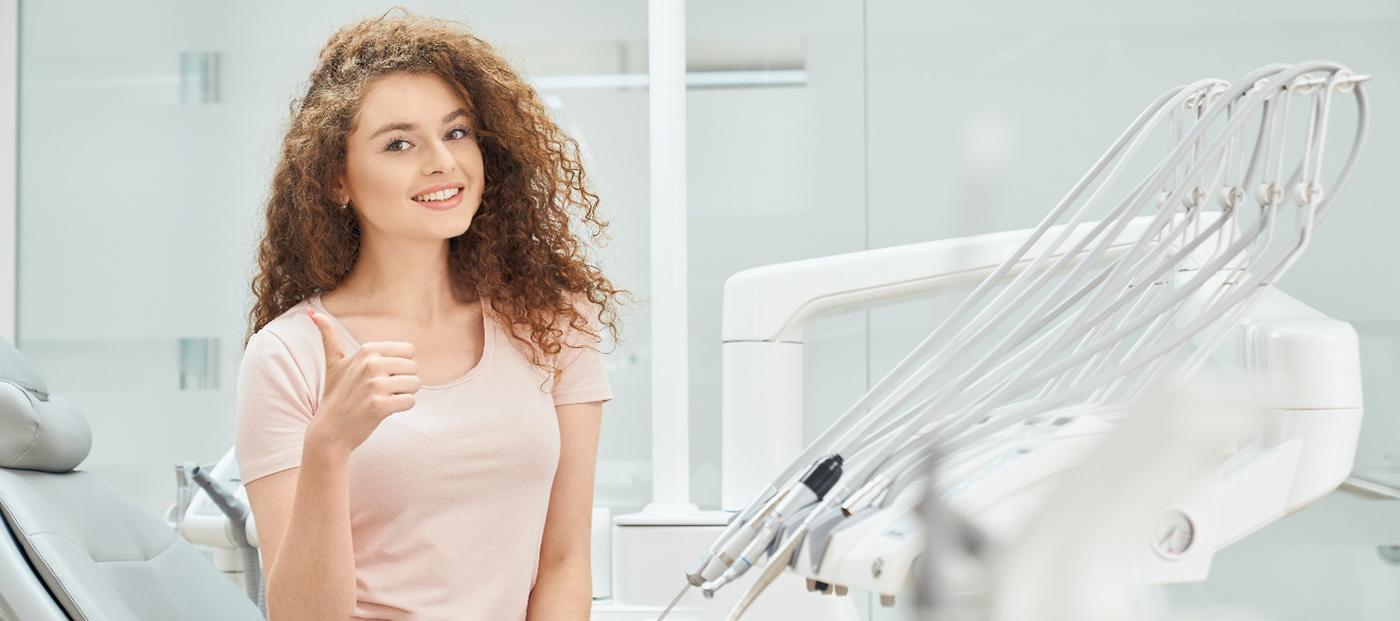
[0,0,20,344]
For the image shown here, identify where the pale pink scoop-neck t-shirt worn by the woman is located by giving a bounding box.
[234,295,612,620]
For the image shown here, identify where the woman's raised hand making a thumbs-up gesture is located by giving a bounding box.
[307,308,421,455]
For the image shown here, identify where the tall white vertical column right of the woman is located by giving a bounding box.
[645,0,696,513]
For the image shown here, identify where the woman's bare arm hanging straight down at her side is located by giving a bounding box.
[526,401,603,621]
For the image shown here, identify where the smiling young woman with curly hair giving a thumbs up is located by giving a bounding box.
[235,11,626,621]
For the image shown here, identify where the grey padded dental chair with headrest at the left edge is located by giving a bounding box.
[0,338,263,621]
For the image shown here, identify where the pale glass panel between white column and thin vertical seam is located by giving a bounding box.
[686,1,867,506]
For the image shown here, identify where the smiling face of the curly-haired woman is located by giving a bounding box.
[340,74,484,241]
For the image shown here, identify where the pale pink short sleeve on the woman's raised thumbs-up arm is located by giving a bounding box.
[234,330,315,484]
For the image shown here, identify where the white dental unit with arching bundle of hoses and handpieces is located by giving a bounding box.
[664,62,1368,618]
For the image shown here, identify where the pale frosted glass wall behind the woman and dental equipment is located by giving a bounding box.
[17,0,1400,620]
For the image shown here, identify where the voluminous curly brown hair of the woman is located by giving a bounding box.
[244,7,630,371]
